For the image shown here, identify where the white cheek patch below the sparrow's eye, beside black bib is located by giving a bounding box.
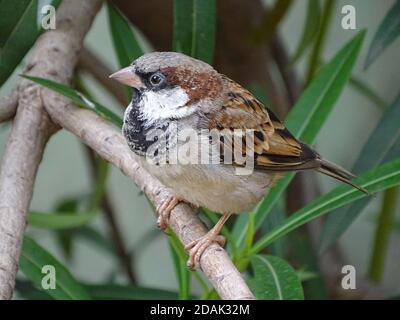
[140,87,194,125]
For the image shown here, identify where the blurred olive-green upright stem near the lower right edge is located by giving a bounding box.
[368,187,398,283]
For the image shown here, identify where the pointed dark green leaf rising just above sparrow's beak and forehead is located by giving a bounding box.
[107,2,144,68]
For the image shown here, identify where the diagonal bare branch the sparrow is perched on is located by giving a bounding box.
[43,90,254,299]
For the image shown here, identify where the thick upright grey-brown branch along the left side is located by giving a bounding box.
[0,0,101,299]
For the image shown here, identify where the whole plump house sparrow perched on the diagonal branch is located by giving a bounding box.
[110,52,365,268]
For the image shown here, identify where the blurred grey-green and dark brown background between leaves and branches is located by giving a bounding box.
[0,0,400,300]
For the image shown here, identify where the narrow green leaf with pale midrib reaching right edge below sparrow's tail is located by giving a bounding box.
[250,159,400,254]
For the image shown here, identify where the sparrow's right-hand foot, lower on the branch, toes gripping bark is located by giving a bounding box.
[185,230,225,270]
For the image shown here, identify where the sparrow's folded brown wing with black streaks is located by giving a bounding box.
[210,77,318,171]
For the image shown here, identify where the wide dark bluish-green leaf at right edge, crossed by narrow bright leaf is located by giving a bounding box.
[320,96,400,251]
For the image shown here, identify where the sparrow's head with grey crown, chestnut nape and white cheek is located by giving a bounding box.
[110,52,222,122]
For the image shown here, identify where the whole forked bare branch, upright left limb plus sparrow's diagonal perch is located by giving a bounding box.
[0,0,254,299]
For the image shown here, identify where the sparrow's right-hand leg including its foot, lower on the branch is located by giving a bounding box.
[185,213,231,270]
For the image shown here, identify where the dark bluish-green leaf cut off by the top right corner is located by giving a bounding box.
[364,0,400,69]
